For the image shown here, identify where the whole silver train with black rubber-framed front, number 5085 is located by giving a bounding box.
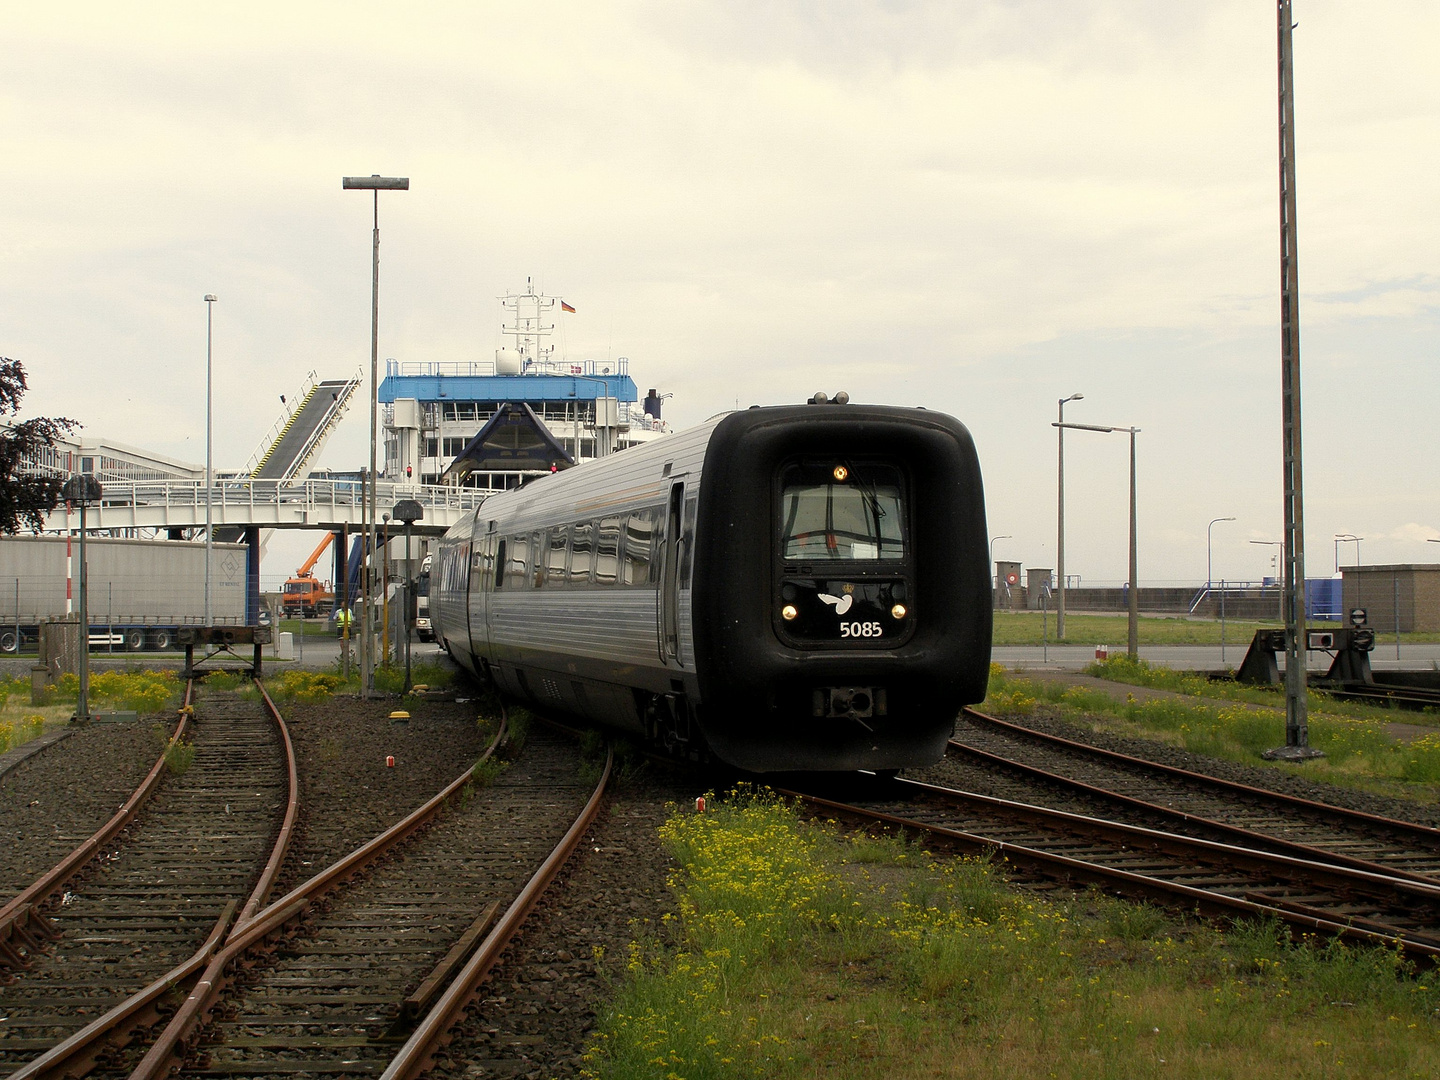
[431,395,991,772]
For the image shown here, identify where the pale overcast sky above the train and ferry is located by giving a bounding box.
[0,0,1440,593]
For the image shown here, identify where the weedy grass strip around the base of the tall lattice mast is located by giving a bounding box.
[981,660,1440,801]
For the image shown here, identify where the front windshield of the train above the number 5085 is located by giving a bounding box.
[780,464,904,562]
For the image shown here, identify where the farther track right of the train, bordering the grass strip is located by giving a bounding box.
[948,710,1440,884]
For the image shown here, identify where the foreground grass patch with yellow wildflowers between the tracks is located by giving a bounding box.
[586,793,1440,1080]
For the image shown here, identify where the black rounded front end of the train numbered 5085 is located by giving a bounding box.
[693,405,991,772]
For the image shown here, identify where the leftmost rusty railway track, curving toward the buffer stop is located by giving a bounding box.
[0,685,295,1073]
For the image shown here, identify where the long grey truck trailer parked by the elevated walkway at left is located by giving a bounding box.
[0,536,246,652]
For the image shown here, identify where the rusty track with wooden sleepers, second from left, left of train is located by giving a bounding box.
[0,711,611,1080]
